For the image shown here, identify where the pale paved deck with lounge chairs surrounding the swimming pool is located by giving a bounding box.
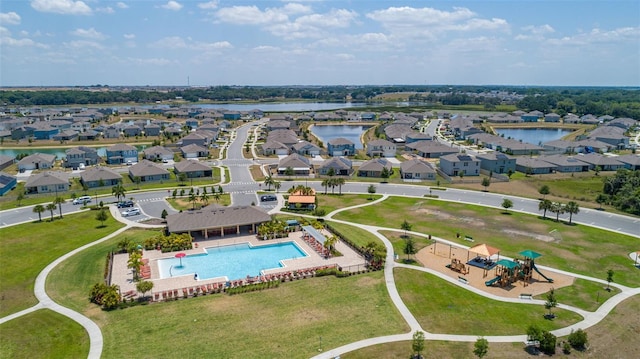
[111,230,365,298]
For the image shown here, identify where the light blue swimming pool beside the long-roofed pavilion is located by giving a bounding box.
[158,242,307,280]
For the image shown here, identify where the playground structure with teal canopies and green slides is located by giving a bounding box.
[485,250,553,287]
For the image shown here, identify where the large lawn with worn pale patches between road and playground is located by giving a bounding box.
[335,197,640,286]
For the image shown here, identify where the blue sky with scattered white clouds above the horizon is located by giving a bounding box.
[0,0,640,86]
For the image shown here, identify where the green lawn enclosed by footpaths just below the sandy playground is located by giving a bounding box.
[394,268,582,336]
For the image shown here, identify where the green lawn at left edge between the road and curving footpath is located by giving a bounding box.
[0,211,123,316]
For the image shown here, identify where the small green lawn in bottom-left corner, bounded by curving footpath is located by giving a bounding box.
[0,309,89,359]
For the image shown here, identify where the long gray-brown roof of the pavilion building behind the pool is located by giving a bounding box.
[167,206,271,232]
